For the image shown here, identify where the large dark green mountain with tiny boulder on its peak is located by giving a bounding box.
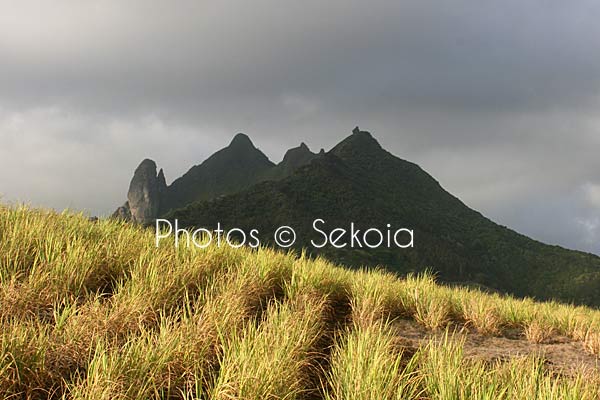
[166,129,600,305]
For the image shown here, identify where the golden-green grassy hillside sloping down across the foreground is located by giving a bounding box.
[0,206,600,400]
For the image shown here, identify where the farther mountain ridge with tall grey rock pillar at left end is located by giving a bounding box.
[113,133,322,225]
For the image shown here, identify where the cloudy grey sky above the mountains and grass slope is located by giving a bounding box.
[0,0,600,254]
